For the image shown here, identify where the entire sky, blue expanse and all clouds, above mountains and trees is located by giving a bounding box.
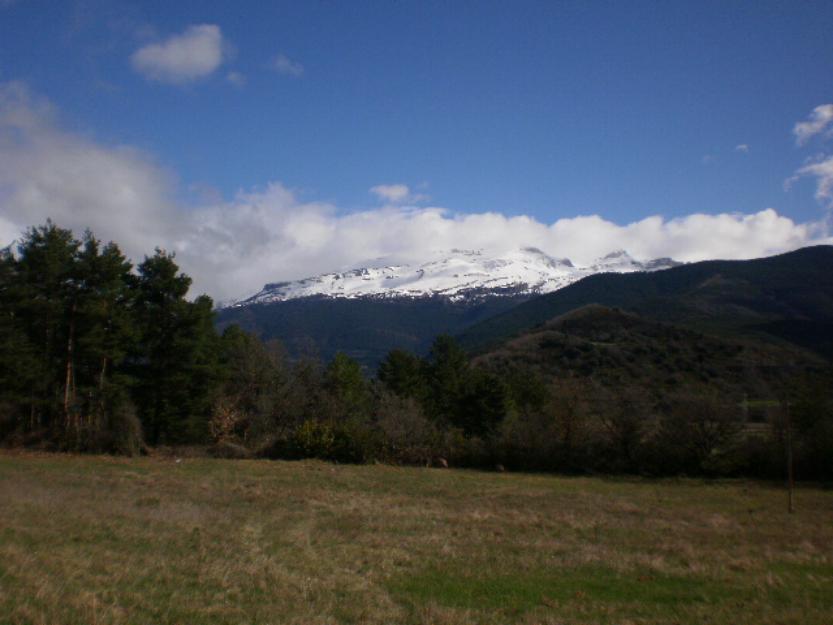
[0,0,833,301]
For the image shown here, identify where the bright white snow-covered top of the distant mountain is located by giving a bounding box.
[231,247,680,307]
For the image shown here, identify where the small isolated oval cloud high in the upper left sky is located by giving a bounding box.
[130,24,224,84]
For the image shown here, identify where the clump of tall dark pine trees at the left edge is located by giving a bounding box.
[0,221,220,451]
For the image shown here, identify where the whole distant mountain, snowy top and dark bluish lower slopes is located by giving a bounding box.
[218,247,678,368]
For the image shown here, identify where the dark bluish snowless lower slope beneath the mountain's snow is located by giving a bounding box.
[217,296,528,368]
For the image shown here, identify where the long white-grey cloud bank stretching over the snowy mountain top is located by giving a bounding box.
[0,83,833,300]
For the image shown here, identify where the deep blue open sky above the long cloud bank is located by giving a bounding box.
[0,0,833,298]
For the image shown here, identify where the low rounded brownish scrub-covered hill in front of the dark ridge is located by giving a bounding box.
[475,305,823,402]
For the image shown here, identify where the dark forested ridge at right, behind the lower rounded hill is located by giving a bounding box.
[460,246,833,358]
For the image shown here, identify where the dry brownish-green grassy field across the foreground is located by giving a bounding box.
[0,453,833,625]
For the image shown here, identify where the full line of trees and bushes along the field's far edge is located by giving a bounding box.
[0,222,833,478]
